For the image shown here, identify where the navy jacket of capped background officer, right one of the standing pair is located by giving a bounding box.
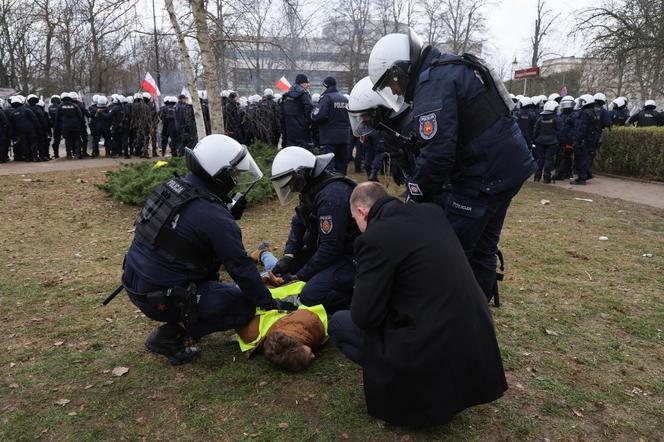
[311,87,350,145]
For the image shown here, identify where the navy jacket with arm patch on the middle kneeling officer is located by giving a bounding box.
[284,176,359,281]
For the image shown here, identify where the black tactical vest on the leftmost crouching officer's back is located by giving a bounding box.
[134,178,223,276]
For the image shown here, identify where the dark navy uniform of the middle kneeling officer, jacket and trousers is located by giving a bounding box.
[284,174,359,312]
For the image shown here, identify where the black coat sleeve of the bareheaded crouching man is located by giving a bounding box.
[350,236,395,330]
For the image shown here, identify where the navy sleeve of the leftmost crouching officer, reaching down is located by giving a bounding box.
[204,209,272,308]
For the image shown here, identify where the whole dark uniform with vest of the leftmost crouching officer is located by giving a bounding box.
[122,173,274,338]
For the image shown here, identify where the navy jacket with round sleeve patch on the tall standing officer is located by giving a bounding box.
[408,49,536,199]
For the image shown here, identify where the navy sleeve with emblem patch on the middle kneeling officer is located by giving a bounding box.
[297,188,353,281]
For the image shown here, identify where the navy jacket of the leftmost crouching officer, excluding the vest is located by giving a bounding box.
[123,173,272,306]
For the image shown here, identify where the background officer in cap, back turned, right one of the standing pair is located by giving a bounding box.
[311,77,350,175]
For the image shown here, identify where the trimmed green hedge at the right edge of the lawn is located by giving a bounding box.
[595,127,664,181]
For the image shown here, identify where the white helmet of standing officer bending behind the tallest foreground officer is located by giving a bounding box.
[348,77,392,137]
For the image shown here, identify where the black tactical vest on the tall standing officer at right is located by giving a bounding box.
[430,54,511,144]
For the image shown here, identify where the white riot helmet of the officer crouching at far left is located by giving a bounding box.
[185,134,263,196]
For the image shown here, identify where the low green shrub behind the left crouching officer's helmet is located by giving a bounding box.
[97,143,277,206]
